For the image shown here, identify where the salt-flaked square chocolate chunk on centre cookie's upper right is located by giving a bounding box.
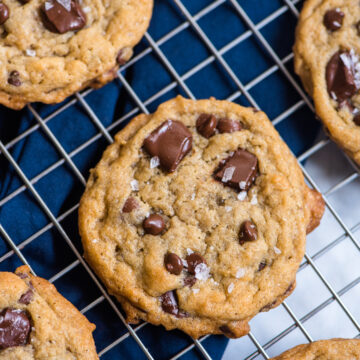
[214,149,257,191]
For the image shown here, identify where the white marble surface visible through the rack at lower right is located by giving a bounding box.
[223,136,360,360]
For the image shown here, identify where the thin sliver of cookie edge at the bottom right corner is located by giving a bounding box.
[273,339,360,360]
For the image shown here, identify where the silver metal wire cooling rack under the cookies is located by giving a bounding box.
[0,0,360,359]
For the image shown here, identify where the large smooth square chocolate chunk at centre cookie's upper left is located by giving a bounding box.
[144,120,192,172]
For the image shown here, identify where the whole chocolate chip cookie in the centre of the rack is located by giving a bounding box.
[79,97,324,338]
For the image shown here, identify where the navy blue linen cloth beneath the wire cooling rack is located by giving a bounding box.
[0,0,319,359]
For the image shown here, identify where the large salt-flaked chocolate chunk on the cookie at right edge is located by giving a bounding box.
[326,50,357,102]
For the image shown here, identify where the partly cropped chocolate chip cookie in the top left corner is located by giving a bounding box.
[0,0,153,109]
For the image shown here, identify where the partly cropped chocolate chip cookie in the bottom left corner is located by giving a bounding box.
[0,266,99,360]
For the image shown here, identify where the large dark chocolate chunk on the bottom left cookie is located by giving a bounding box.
[0,308,31,350]
